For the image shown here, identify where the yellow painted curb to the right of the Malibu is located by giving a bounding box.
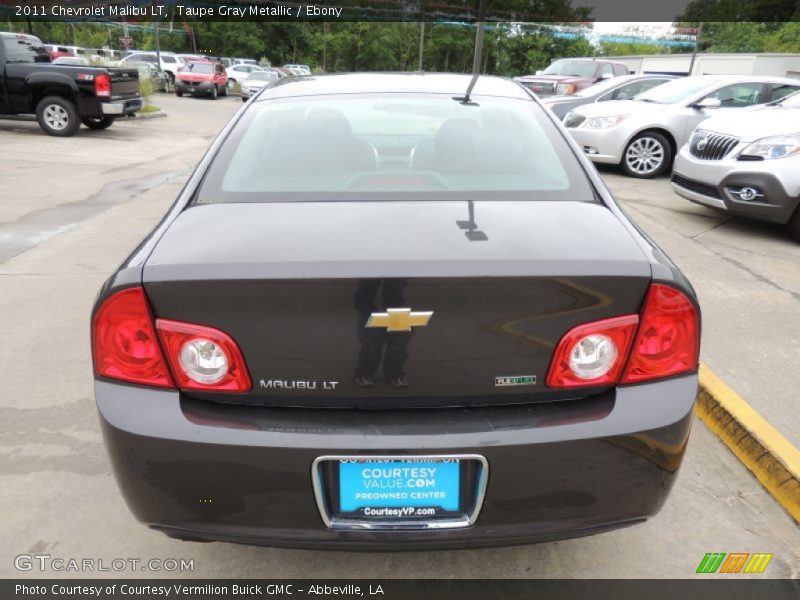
[695,364,800,522]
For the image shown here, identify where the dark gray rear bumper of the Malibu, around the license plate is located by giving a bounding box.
[95,375,697,550]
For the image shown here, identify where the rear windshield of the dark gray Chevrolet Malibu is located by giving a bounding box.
[195,94,594,203]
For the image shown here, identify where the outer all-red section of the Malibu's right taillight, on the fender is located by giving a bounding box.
[621,283,700,383]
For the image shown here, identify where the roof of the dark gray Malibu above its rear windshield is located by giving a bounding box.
[258,73,531,100]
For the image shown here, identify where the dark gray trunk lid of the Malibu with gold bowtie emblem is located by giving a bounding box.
[143,201,651,407]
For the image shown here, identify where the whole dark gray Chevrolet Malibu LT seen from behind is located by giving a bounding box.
[92,74,700,549]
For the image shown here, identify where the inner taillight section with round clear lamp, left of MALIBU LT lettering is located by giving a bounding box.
[156,319,251,392]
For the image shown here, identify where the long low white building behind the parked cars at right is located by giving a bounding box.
[604,53,800,79]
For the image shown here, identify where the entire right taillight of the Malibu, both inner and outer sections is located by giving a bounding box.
[546,283,700,388]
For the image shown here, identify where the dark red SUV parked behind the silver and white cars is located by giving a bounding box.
[515,58,630,98]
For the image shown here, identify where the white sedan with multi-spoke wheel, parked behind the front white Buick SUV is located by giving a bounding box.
[564,75,800,178]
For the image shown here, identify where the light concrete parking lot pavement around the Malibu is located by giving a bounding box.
[0,97,800,578]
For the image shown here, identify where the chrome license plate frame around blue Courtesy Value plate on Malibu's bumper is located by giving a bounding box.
[311,454,489,529]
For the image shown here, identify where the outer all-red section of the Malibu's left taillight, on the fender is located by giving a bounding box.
[92,287,175,388]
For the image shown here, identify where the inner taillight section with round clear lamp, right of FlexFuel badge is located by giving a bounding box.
[547,315,639,388]
